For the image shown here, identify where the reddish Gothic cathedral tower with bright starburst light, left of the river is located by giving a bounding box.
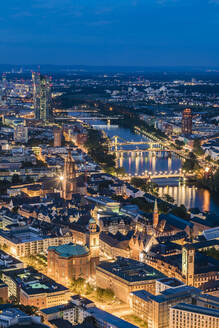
[62,149,77,200]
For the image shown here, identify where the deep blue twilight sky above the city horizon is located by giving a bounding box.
[0,0,219,66]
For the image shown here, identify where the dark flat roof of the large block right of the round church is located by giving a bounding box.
[97,257,165,282]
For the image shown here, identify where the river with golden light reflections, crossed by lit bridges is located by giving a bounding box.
[70,113,219,215]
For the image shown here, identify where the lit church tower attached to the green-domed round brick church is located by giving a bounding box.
[87,218,100,275]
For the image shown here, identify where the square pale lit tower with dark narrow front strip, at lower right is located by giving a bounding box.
[182,244,195,286]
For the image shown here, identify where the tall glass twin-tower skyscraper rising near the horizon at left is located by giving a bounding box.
[32,72,52,121]
